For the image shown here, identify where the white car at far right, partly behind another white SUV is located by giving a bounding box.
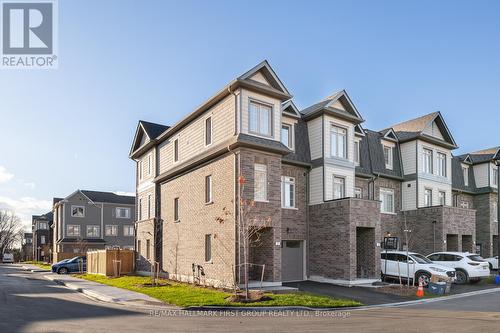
[427,252,490,284]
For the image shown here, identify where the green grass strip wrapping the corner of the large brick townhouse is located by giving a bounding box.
[75,274,362,308]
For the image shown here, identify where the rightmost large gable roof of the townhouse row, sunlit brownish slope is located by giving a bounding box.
[384,111,457,148]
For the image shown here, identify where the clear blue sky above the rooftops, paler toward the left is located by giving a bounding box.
[0,0,500,228]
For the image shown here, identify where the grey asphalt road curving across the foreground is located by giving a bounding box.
[0,265,500,333]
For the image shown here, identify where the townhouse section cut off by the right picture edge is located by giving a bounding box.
[453,147,500,258]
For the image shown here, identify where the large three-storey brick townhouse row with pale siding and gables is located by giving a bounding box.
[130,61,494,286]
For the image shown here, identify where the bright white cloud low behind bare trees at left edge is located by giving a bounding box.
[0,196,52,229]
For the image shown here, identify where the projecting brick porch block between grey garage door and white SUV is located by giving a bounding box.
[308,198,380,280]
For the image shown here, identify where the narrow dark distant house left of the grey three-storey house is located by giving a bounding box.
[31,212,53,262]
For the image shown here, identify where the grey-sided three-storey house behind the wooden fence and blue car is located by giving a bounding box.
[53,190,135,261]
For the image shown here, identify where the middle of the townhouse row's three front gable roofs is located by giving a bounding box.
[300,90,364,123]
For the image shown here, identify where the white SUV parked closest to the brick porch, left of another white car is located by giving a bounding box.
[380,251,455,286]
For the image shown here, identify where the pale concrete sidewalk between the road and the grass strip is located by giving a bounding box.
[44,273,170,308]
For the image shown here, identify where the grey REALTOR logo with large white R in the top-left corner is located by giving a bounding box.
[0,0,58,69]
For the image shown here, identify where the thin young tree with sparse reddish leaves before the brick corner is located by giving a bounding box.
[216,176,272,300]
